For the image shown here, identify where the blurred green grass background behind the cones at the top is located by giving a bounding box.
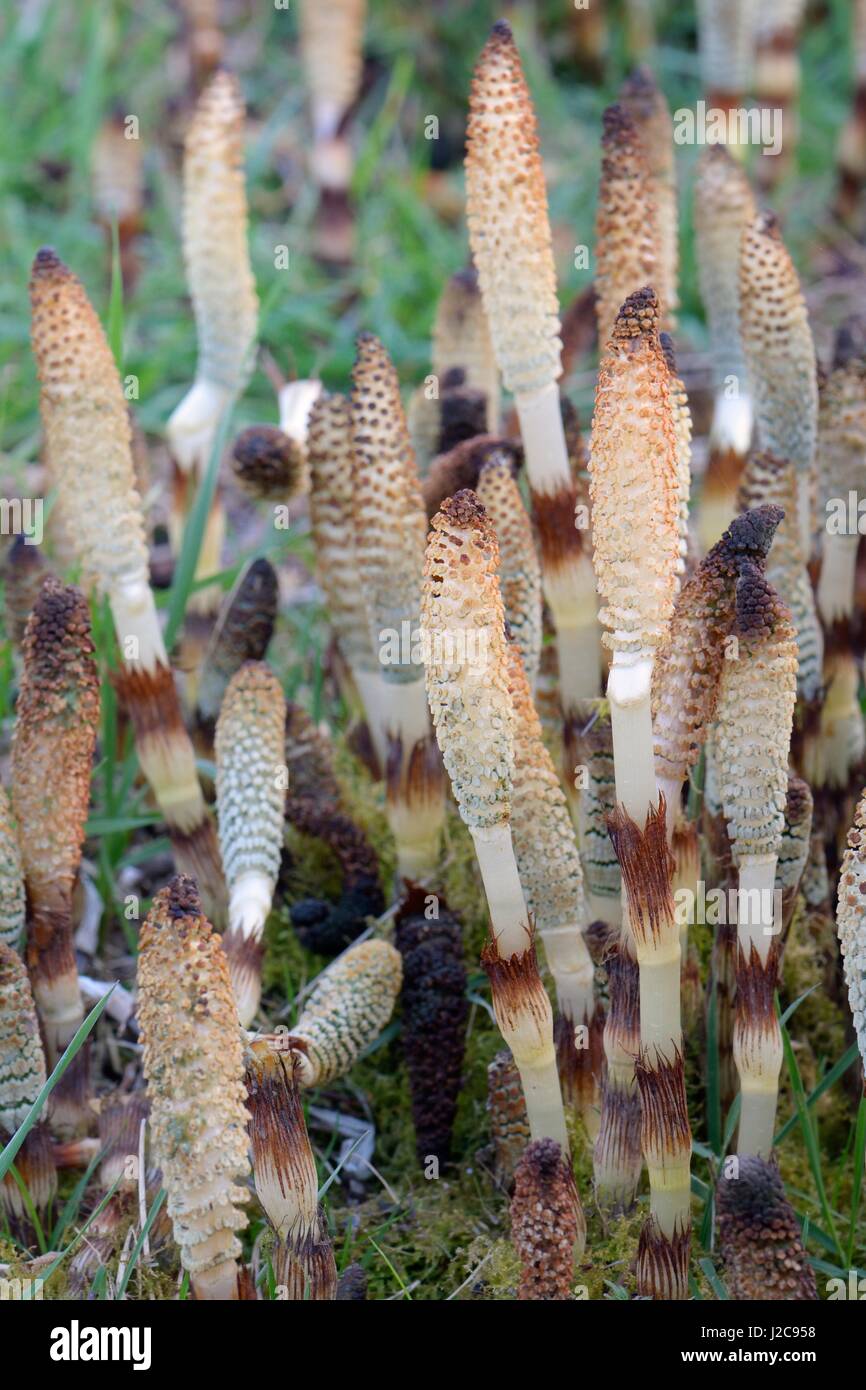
[0,0,853,460]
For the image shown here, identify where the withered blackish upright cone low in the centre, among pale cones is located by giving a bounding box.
[393,887,468,1166]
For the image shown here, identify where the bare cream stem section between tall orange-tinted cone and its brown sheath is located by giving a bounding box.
[607,653,659,830]
